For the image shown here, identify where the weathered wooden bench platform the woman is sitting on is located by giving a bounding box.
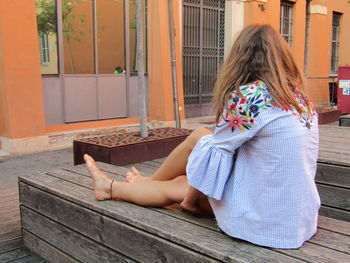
[19,160,350,263]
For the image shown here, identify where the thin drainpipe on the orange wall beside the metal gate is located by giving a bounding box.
[169,0,181,128]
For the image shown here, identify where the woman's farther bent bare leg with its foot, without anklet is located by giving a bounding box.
[126,128,213,183]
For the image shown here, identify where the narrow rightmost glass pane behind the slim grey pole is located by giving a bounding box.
[129,0,147,72]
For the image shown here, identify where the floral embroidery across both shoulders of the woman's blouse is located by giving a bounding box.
[217,81,316,132]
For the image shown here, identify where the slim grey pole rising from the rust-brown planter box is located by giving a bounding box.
[136,0,148,137]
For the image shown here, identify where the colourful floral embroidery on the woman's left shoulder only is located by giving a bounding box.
[218,81,272,132]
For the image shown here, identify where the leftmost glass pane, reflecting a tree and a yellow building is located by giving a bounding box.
[35,0,58,74]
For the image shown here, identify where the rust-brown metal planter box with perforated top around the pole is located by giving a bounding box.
[73,128,192,165]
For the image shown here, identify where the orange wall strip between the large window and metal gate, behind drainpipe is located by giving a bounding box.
[148,0,183,121]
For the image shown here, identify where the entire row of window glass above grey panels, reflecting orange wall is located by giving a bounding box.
[35,0,147,75]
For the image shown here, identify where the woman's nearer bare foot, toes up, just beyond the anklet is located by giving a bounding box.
[84,154,112,200]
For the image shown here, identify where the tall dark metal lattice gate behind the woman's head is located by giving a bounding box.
[183,0,225,117]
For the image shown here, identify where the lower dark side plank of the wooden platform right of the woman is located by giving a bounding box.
[316,184,350,211]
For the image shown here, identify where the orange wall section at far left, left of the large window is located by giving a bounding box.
[0,0,45,139]
